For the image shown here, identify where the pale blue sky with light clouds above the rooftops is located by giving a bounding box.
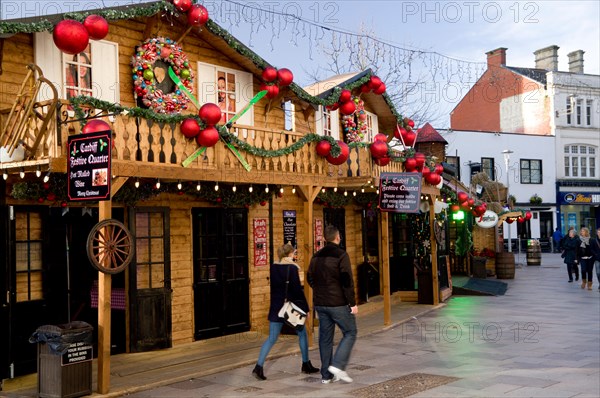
[0,0,600,128]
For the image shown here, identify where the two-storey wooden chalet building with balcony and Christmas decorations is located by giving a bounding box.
[0,1,439,391]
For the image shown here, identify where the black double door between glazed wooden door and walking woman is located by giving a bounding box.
[192,209,250,340]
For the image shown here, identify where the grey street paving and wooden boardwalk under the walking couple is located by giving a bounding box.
[0,253,600,398]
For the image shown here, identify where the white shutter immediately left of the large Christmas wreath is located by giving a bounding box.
[90,40,120,103]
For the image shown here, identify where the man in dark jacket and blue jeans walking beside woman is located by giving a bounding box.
[307,225,358,384]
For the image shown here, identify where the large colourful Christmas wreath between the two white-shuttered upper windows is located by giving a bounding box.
[131,37,194,113]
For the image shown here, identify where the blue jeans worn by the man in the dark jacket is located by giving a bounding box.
[315,305,357,380]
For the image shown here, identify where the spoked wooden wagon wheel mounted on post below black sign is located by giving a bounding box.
[87,219,134,274]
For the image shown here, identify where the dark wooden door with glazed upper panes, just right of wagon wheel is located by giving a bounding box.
[129,207,172,352]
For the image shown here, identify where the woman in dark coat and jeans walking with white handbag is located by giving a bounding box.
[252,244,319,380]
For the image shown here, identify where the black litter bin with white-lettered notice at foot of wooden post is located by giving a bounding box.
[29,322,94,398]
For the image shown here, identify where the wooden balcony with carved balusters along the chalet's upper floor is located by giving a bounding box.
[0,101,402,187]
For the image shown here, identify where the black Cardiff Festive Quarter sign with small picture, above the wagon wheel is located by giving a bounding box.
[67,131,111,201]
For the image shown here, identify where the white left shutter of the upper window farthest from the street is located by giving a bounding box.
[33,32,65,101]
